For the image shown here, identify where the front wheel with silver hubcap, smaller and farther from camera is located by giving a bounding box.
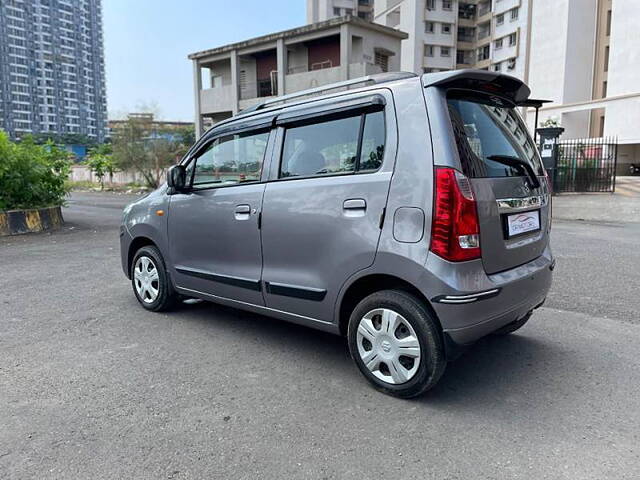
[131,246,178,312]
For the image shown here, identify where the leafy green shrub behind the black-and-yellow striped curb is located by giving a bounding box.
[0,131,70,210]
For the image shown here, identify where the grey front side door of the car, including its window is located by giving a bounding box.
[168,130,269,305]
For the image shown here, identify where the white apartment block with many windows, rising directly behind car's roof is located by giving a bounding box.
[307,0,531,80]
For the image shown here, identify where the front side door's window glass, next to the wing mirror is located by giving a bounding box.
[193,132,269,186]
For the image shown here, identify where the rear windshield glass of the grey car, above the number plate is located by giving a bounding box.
[447,94,544,178]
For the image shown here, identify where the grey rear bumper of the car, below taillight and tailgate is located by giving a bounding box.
[428,247,555,345]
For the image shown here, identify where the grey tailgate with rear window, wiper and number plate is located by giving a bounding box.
[447,90,550,274]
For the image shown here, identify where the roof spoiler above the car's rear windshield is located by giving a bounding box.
[422,69,531,106]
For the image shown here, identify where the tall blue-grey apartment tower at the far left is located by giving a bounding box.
[0,0,107,142]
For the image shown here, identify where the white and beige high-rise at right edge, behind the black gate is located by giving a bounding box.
[528,0,640,173]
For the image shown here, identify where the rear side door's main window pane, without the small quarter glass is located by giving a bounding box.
[280,116,360,177]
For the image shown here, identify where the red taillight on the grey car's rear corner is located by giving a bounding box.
[430,168,480,262]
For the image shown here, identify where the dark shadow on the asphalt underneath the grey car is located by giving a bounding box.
[174,302,560,410]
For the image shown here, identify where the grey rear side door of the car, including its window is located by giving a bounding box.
[262,91,396,322]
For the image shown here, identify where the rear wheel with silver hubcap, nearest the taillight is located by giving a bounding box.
[347,290,447,398]
